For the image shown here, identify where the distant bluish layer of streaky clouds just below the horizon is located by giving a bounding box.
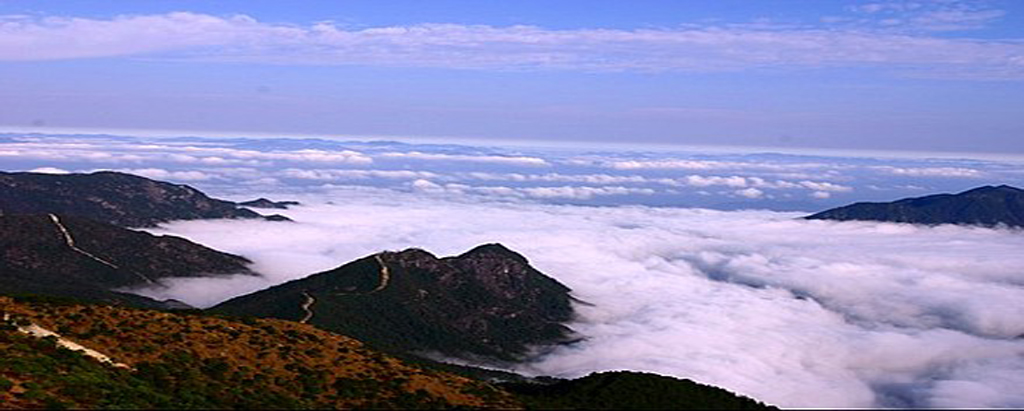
[8,134,1024,212]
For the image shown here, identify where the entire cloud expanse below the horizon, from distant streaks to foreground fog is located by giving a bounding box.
[0,135,1024,407]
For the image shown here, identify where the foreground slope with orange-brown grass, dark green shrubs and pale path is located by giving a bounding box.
[0,297,773,409]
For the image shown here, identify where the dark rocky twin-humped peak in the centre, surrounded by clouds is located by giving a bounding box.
[212,244,573,361]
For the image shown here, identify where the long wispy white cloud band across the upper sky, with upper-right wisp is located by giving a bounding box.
[0,8,1024,79]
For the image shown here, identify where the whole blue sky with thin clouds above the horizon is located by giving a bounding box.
[0,0,1024,154]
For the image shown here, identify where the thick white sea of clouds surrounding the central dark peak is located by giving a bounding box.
[136,188,1024,408]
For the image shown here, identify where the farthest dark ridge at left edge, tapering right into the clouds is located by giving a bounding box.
[0,171,287,227]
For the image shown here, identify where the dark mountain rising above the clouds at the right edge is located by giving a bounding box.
[806,186,1024,227]
